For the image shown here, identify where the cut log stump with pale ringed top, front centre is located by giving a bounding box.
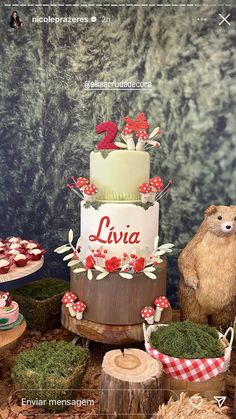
[100,349,163,419]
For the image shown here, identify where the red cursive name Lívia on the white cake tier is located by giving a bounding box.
[89,216,140,244]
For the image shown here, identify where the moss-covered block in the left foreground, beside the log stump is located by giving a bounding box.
[11,341,88,412]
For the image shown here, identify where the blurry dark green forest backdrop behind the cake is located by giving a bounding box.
[0,1,236,302]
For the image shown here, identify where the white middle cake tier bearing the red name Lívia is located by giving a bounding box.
[81,201,159,257]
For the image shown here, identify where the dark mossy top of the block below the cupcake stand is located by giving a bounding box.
[14,278,69,301]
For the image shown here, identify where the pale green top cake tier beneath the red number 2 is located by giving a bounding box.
[90,150,150,201]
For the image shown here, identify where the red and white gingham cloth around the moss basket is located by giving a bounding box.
[146,345,225,381]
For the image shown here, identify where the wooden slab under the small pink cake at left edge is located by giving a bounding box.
[0,320,27,358]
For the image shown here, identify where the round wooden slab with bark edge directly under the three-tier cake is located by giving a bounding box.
[61,306,172,345]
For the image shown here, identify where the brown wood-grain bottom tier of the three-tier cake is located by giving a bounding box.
[71,258,167,325]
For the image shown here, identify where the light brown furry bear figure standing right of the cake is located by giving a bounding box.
[178,205,236,329]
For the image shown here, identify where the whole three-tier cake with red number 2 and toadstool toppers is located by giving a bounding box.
[56,114,173,325]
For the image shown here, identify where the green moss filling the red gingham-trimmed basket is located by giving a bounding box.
[150,321,224,359]
